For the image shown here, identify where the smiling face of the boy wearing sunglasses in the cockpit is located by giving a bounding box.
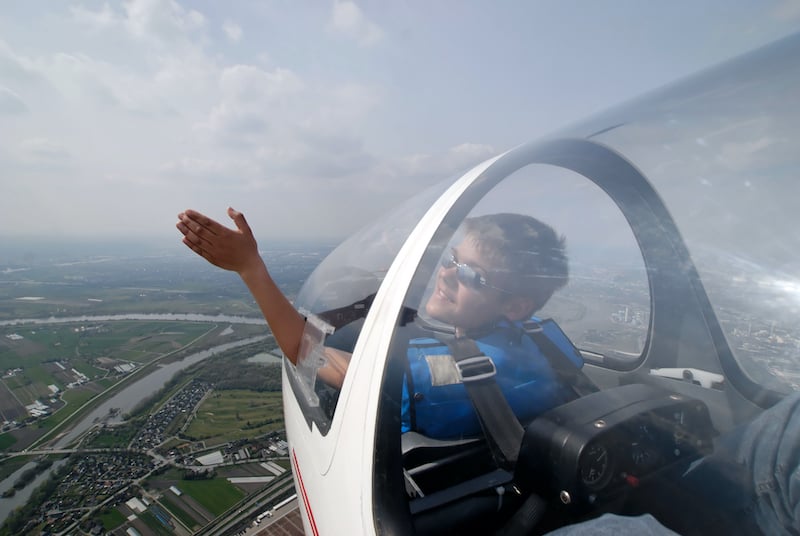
[425,236,508,330]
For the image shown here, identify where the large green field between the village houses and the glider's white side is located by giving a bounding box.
[185,390,283,444]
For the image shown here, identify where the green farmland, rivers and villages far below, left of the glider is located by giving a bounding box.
[0,244,330,535]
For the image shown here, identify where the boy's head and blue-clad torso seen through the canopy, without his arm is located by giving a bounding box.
[401,214,577,438]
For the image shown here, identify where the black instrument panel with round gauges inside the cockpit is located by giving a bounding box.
[515,384,716,505]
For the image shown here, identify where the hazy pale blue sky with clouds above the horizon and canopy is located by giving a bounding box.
[0,0,800,247]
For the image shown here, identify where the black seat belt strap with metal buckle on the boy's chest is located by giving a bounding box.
[447,338,525,466]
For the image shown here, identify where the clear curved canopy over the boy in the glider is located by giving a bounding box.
[290,32,800,533]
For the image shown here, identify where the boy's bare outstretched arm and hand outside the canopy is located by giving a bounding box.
[175,208,305,364]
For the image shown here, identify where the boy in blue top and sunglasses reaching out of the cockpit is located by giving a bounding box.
[176,209,568,438]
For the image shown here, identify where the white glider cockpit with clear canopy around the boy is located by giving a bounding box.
[284,31,800,534]
